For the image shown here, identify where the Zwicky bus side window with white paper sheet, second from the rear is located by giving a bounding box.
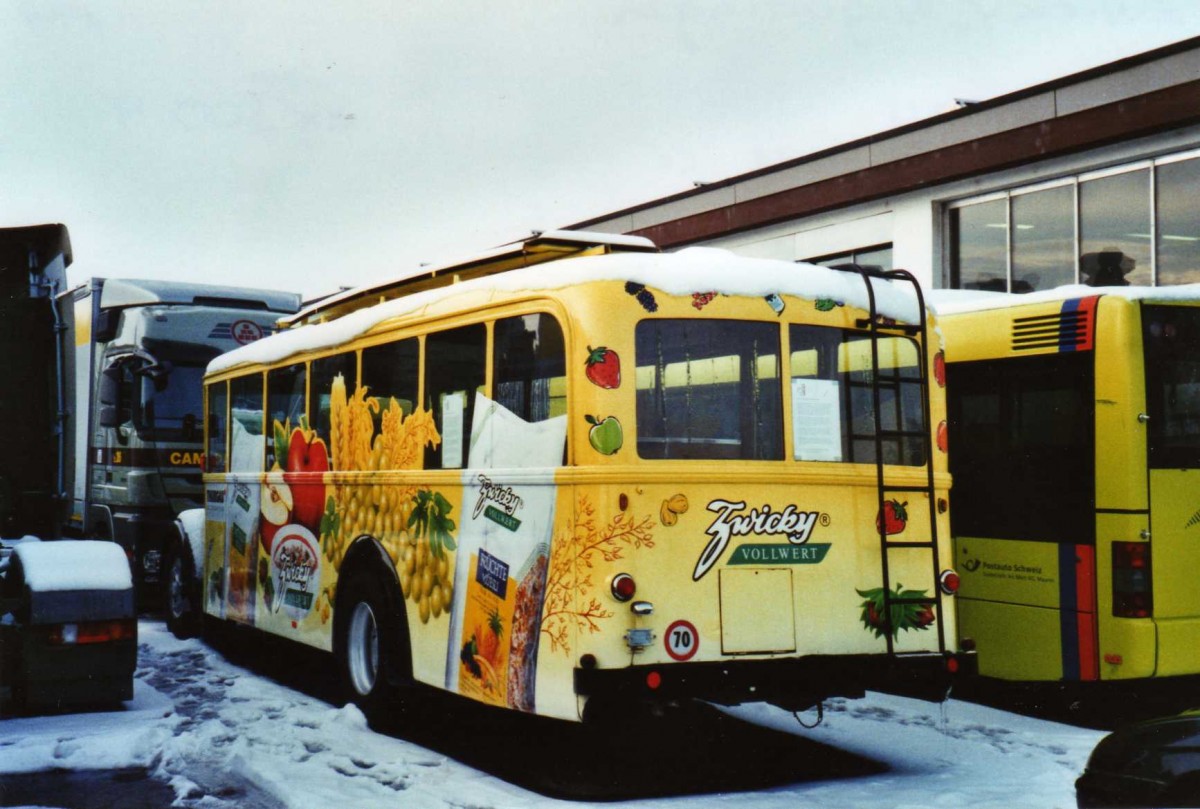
[425,323,487,469]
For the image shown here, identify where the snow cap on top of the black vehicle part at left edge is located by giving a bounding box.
[14,539,133,593]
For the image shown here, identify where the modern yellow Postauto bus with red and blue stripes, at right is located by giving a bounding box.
[937,286,1200,682]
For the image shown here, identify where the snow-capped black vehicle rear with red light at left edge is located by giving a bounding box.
[0,540,138,715]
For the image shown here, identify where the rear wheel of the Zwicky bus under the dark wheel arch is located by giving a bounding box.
[334,573,403,720]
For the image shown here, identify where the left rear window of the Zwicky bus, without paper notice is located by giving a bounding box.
[635,319,784,461]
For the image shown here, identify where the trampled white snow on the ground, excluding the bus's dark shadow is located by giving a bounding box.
[0,622,1104,809]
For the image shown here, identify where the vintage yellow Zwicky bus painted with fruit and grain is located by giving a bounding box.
[174,233,970,720]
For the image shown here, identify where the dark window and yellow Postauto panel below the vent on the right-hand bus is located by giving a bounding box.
[947,344,1098,681]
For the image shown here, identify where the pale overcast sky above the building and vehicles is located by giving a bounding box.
[0,0,1200,296]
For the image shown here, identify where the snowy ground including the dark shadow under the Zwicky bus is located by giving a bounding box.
[0,622,1103,809]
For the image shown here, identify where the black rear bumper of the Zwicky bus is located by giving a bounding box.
[575,653,974,713]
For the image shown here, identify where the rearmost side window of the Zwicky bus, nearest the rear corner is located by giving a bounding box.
[492,314,566,421]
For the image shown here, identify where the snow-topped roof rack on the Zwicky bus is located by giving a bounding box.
[278,230,659,329]
